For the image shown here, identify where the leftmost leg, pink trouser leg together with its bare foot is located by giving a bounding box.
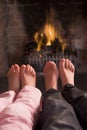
[0,64,20,112]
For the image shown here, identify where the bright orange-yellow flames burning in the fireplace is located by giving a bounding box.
[34,23,66,51]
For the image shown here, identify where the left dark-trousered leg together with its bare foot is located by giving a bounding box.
[40,62,81,130]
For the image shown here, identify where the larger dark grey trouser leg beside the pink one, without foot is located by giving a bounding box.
[39,89,82,130]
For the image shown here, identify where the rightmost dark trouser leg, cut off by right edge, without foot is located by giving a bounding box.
[62,84,87,130]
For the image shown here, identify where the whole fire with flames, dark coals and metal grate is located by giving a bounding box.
[24,21,77,72]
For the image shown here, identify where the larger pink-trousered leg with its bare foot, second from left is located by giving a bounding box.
[0,65,41,130]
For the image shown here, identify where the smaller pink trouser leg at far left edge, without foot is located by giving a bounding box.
[0,90,16,113]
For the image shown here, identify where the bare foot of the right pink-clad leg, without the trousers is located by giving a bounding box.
[21,65,36,87]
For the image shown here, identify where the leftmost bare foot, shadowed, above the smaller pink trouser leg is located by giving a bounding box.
[7,64,20,93]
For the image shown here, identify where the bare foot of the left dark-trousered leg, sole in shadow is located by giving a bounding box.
[44,61,58,91]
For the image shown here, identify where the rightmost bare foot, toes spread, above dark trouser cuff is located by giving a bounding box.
[59,58,75,87]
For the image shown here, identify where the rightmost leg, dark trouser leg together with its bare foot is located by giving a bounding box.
[59,59,87,129]
